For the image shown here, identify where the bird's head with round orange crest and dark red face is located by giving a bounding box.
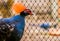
[12,3,32,16]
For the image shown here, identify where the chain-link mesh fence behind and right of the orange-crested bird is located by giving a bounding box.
[13,0,60,41]
